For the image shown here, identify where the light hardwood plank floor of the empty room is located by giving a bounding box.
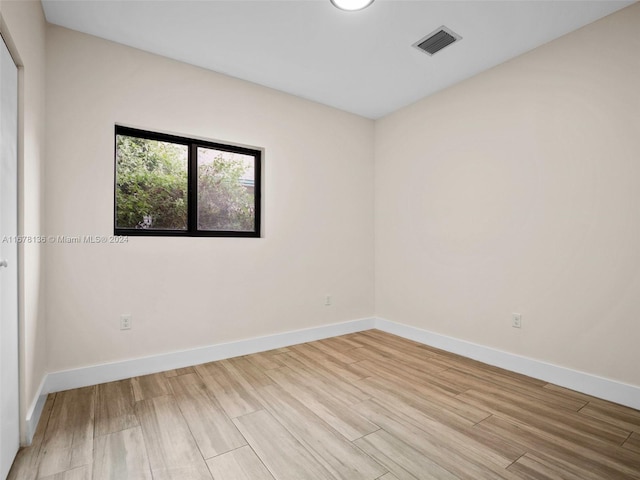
[9,330,640,480]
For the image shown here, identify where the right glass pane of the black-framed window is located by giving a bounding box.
[198,147,255,232]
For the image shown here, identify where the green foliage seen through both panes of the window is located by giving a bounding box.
[116,131,255,232]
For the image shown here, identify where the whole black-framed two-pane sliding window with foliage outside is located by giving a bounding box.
[115,125,261,237]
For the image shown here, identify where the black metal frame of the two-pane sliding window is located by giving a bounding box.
[113,124,262,238]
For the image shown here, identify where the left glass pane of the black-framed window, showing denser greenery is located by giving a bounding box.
[116,135,188,230]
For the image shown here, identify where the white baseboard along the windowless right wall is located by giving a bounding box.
[374,318,640,410]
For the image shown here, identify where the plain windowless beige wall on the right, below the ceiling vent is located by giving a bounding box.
[375,4,640,385]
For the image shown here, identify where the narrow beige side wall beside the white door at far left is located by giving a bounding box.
[0,0,46,438]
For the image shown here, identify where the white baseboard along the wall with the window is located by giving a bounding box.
[43,318,375,394]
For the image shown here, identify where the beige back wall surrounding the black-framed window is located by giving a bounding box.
[46,26,374,371]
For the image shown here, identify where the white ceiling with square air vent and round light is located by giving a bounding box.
[42,0,634,118]
